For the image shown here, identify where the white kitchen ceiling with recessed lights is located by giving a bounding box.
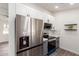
[32,3,79,12]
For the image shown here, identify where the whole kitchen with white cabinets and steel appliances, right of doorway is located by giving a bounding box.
[0,3,79,56]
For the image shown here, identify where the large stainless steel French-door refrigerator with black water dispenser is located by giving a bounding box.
[15,15,44,56]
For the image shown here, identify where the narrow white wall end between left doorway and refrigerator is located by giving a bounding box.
[9,3,16,56]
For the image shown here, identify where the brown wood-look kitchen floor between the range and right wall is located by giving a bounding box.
[50,48,79,56]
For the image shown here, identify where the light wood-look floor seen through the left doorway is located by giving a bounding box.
[0,42,9,56]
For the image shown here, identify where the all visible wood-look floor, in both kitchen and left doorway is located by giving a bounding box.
[0,43,79,56]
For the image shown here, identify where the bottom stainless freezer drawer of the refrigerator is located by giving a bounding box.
[17,45,43,56]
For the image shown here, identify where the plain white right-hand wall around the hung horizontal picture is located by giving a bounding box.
[55,9,79,54]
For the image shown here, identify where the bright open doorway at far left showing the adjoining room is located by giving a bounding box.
[0,3,9,56]
